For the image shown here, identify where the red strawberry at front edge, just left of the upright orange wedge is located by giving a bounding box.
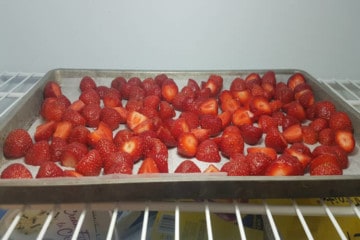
[103,152,134,174]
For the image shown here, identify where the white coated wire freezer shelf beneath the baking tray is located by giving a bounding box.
[0,72,360,240]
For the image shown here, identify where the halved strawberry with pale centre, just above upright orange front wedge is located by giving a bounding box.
[119,136,144,163]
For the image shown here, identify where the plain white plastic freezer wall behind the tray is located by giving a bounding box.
[0,0,360,79]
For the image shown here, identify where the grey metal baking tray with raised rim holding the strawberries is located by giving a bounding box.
[0,69,360,205]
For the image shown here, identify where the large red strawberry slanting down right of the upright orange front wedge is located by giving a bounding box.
[144,138,169,173]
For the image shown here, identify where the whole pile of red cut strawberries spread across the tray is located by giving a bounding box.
[1,71,355,178]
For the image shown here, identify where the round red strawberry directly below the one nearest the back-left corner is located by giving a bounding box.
[40,97,66,122]
